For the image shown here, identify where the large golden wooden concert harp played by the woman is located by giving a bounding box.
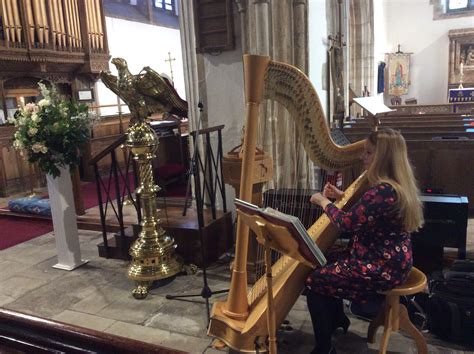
[208,55,366,352]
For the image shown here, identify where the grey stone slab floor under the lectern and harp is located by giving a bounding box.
[0,223,474,353]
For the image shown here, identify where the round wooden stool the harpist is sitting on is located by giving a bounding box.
[367,267,428,354]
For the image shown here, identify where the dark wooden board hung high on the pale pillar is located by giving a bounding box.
[194,0,234,53]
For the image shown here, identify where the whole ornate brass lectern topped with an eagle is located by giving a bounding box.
[100,58,188,299]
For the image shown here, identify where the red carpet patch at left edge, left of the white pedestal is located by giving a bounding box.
[0,215,53,250]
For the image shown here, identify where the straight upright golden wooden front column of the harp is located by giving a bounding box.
[224,55,270,319]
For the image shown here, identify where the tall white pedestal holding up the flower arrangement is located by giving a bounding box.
[46,167,88,270]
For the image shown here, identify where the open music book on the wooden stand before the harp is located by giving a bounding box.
[235,198,327,266]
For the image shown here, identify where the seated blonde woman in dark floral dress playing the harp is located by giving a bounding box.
[306,129,423,353]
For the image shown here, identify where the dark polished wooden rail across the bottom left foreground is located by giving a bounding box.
[0,309,184,354]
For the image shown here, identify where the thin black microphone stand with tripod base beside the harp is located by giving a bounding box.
[166,101,229,323]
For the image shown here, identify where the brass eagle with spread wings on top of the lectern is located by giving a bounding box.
[100,58,188,123]
